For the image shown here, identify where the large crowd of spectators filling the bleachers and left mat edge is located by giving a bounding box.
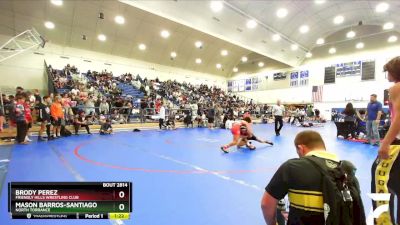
[0,64,286,143]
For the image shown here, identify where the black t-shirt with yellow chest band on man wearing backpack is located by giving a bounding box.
[265,152,334,225]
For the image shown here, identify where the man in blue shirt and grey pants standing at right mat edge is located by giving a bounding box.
[365,94,382,146]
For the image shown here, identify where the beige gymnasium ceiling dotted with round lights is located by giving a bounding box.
[0,0,400,76]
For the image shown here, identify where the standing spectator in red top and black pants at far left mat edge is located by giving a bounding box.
[13,94,28,144]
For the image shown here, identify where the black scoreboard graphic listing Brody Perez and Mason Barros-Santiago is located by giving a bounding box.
[8,182,132,219]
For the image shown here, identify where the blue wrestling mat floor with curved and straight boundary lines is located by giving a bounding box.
[0,123,378,225]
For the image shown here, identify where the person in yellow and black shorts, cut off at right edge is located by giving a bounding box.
[371,57,400,225]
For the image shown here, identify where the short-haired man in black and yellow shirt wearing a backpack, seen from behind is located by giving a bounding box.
[261,131,366,225]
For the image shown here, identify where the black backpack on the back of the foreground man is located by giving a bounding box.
[304,156,366,225]
